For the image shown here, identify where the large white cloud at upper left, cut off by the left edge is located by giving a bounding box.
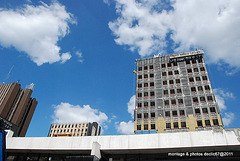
[0,2,75,65]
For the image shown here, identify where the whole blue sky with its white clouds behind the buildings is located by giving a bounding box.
[0,0,240,136]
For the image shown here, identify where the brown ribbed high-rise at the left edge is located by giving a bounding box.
[0,83,38,137]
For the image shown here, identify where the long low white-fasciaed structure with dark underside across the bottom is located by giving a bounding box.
[6,129,240,161]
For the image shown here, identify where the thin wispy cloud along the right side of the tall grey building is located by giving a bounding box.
[213,88,235,126]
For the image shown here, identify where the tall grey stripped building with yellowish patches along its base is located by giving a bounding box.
[134,50,223,134]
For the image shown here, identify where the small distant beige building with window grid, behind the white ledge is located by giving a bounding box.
[48,122,101,137]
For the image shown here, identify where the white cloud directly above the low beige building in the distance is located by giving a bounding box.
[53,102,108,125]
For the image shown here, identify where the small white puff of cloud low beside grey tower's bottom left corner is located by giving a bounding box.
[116,121,134,135]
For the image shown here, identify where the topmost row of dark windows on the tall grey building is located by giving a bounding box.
[138,59,203,71]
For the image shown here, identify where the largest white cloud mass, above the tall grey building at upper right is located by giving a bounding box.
[109,0,240,68]
